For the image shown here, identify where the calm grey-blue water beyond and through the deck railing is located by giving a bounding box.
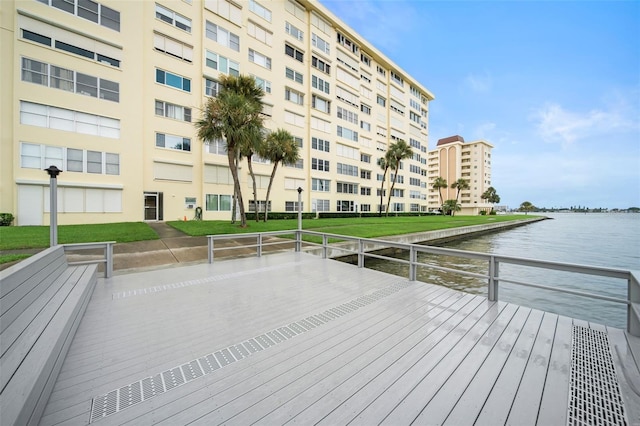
[366,213,640,328]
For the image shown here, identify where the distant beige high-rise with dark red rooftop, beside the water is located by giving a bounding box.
[427,135,493,215]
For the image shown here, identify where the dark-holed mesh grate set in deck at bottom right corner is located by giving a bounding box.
[567,326,627,426]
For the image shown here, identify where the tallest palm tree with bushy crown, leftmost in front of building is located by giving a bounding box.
[195,75,264,228]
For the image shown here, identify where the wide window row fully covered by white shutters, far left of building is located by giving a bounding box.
[20,101,120,139]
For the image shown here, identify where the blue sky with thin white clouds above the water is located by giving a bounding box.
[321,0,640,208]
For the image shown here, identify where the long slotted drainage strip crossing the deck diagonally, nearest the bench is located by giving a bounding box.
[89,280,414,423]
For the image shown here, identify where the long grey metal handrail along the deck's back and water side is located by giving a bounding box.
[207,229,640,336]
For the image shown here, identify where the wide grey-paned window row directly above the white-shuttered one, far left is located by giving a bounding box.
[22,58,120,102]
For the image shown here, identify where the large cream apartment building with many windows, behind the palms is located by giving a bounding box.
[0,0,434,225]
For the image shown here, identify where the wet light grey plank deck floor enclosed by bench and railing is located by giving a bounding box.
[40,253,640,425]
